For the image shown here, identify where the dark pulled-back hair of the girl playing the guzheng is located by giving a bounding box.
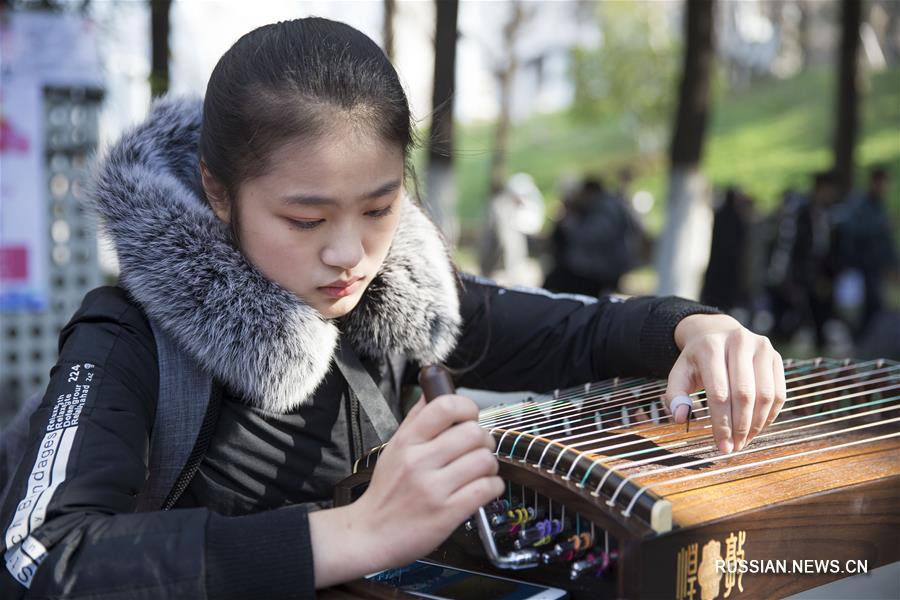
[200,17,416,221]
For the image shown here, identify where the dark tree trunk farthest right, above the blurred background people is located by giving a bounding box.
[834,0,862,194]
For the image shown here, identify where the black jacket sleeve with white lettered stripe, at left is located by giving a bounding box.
[0,288,314,600]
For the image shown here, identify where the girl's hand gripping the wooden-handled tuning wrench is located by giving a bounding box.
[309,395,496,588]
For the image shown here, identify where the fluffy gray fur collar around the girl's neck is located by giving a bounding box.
[89,97,460,413]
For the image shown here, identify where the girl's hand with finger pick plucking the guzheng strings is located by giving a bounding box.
[664,315,786,454]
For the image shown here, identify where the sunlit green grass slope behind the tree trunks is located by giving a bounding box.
[426,68,900,231]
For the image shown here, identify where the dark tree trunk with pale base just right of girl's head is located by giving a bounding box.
[426,0,459,242]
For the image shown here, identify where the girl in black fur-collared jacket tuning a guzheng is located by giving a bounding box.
[0,18,784,598]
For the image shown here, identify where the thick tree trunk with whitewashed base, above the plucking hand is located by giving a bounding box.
[657,0,714,299]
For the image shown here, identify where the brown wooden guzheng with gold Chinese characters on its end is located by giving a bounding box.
[336,359,900,600]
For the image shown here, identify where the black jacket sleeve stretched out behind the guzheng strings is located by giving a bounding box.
[447,276,719,392]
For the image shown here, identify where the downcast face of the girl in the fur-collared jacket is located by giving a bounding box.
[204,126,404,319]
